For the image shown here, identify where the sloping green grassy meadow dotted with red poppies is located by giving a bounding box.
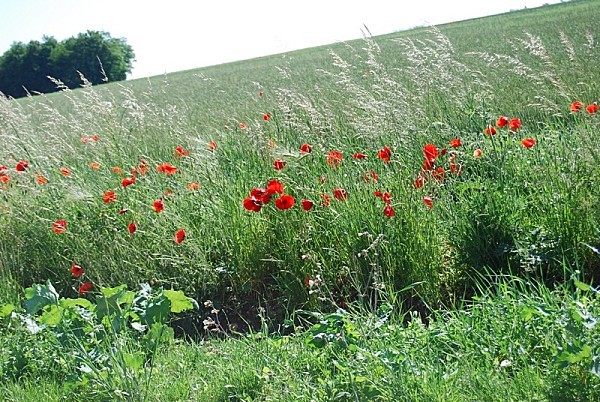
[0,0,600,401]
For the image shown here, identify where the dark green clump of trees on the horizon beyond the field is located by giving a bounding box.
[0,31,135,98]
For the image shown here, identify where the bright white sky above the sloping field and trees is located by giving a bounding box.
[0,0,559,78]
